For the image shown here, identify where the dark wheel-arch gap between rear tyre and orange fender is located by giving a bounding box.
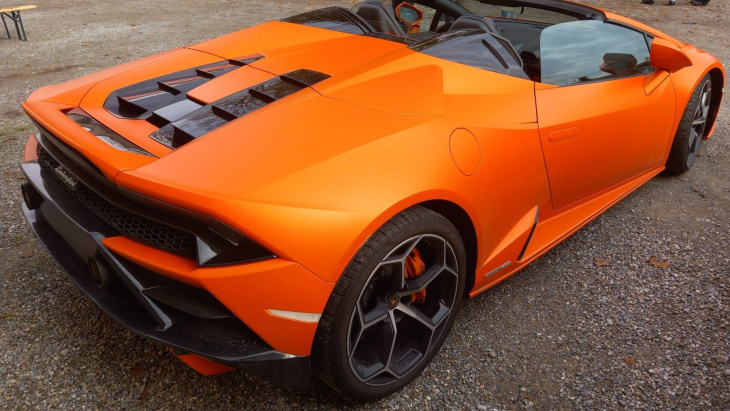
[418,200,478,298]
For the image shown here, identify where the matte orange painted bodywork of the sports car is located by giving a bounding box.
[23,4,724,370]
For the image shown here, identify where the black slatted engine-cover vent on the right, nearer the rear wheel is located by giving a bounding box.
[148,70,330,149]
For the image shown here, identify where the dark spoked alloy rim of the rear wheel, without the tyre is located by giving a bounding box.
[347,234,459,386]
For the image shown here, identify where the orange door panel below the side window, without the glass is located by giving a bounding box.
[535,76,675,209]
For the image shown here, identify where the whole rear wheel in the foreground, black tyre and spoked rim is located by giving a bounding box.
[312,206,466,400]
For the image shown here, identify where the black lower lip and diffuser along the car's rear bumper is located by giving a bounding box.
[22,162,311,388]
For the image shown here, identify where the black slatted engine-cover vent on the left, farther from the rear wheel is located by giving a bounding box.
[104,54,264,123]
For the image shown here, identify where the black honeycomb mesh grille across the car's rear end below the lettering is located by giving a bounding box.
[38,145,196,259]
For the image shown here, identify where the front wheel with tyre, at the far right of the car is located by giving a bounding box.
[666,74,712,174]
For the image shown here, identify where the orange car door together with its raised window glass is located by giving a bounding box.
[535,20,675,209]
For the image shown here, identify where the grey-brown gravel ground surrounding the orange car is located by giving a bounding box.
[0,0,730,410]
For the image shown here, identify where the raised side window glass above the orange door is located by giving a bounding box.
[539,20,654,86]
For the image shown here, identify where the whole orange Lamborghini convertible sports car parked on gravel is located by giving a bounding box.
[21,0,725,399]
